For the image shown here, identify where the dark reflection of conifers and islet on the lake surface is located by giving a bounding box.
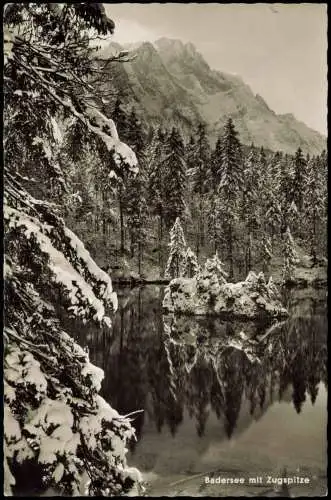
[73,287,327,446]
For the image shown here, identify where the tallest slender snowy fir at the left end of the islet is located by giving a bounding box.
[164,217,187,278]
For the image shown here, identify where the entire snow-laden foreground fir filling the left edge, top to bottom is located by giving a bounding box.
[4,3,140,496]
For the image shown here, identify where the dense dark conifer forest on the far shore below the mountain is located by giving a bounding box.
[62,103,327,278]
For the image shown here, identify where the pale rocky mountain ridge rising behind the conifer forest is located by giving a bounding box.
[98,37,326,154]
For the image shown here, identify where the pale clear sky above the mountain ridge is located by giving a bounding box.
[105,3,327,134]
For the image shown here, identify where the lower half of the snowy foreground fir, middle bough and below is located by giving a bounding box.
[4,181,143,495]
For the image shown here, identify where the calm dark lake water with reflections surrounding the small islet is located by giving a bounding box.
[74,286,327,496]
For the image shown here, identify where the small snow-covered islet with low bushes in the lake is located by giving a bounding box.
[163,271,288,319]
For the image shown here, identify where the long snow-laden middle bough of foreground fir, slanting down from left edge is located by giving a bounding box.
[4,174,117,324]
